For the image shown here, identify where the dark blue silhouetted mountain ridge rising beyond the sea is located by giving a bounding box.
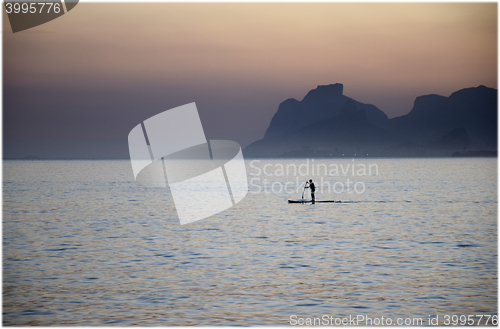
[244,83,497,157]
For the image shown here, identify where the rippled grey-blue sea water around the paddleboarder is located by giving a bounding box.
[3,158,498,326]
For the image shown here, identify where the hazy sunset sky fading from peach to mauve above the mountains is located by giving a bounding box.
[3,3,497,156]
